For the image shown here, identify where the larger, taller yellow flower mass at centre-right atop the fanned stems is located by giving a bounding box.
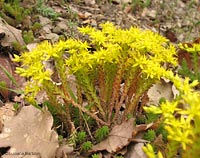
[66,22,177,78]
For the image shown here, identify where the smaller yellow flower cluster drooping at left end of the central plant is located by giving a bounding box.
[13,41,70,96]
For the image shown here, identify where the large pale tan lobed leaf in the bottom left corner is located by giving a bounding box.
[0,106,58,158]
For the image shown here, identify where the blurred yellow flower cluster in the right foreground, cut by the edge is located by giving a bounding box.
[145,72,200,157]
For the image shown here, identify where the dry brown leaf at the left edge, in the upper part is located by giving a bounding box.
[0,18,25,47]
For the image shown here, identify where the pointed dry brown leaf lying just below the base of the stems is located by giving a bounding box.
[91,118,135,153]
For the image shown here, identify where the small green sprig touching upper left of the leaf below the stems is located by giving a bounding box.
[95,126,109,142]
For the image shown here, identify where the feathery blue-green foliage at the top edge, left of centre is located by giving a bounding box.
[36,0,59,20]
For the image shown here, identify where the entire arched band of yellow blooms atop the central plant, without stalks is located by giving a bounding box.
[14,22,177,108]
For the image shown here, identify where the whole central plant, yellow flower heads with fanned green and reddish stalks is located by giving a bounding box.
[14,22,177,134]
